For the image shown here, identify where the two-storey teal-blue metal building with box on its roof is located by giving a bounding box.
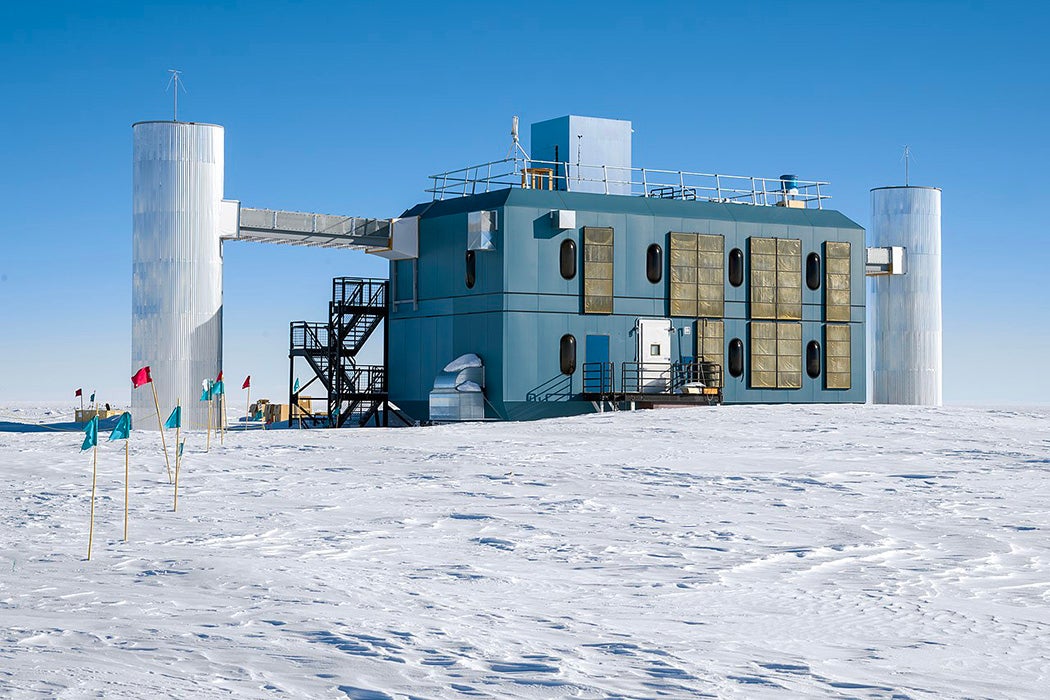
[389,118,865,420]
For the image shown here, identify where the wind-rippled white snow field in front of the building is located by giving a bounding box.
[0,406,1050,700]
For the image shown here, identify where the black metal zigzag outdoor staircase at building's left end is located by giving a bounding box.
[288,277,392,428]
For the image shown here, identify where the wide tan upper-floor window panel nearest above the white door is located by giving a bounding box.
[669,232,726,318]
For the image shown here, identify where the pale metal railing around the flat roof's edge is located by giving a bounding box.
[426,156,831,209]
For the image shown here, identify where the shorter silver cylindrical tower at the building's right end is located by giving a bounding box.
[870,187,942,406]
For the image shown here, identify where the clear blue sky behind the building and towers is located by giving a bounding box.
[0,0,1050,404]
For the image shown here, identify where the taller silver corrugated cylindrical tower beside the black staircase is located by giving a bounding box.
[129,122,224,429]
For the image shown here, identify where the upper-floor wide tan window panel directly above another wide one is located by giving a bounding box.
[748,237,802,321]
